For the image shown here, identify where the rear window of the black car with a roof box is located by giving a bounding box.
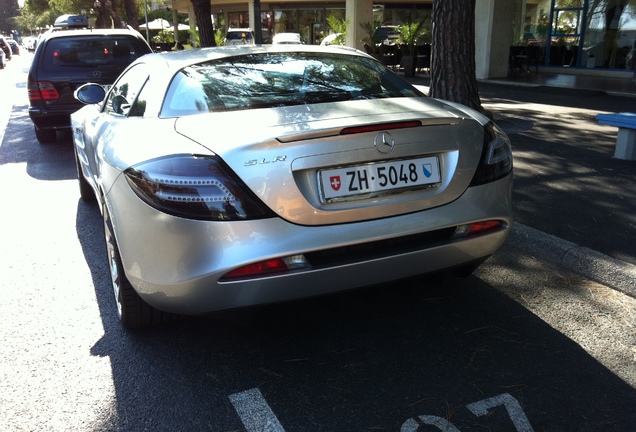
[43,35,150,71]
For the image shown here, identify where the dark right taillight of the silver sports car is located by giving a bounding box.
[470,122,512,186]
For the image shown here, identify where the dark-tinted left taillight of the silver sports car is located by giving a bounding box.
[124,155,274,221]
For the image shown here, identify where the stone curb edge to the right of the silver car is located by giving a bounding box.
[507,223,636,298]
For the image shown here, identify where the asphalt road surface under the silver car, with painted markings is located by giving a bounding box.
[0,57,636,432]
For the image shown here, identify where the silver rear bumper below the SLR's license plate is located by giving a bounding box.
[107,171,512,315]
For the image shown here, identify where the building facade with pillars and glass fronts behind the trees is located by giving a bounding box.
[169,0,636,79]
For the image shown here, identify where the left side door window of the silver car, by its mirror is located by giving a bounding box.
[104,63,148,116]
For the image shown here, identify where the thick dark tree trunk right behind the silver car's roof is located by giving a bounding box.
[430,0,489,114]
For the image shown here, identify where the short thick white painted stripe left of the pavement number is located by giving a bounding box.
[229,388,285,432]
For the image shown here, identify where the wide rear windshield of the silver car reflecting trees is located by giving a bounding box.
[162,52,423,117]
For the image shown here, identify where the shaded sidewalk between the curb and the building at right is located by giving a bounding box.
[404,76,636,297]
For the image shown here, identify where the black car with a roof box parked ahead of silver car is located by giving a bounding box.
[27,15,152,143]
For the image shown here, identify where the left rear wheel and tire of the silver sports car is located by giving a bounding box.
[103,204,178,329]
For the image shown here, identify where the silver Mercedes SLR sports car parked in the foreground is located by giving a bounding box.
[72,45,512,327]
